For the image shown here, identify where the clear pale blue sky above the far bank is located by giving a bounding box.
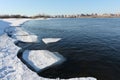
[0,0,120,16]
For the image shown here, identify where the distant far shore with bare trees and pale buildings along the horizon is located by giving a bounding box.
[0,13,120,19]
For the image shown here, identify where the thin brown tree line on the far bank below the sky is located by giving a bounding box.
[0,13,120,18]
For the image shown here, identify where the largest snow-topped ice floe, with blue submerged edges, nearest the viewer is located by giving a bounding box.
[22,50,65,72]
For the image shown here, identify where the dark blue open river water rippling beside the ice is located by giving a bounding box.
[22,18,120,80]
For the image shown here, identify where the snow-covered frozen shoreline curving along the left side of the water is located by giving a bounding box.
[0,19,97,80]
